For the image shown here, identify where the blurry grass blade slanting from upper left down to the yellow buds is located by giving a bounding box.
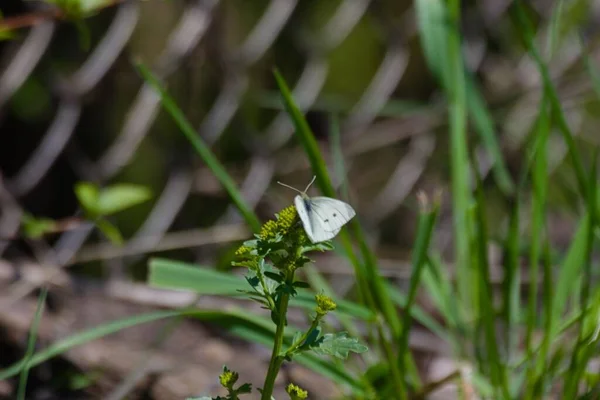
[137,63,261,232]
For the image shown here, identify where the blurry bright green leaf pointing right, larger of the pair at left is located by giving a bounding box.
[96,183,152,216]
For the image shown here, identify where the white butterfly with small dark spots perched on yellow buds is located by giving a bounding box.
[277,176,356,243]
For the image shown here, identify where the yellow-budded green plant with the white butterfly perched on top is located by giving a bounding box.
[151,206,367,400]
